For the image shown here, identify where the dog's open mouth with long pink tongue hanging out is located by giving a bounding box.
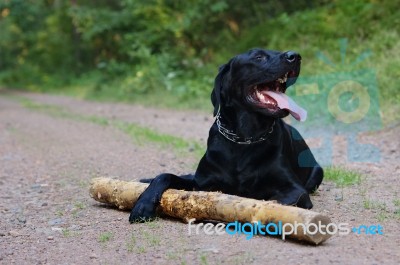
[249,71,307,121]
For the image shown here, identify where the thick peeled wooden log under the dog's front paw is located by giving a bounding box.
[90,178,331,245]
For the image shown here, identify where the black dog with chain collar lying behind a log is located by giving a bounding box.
[129,49,323,223]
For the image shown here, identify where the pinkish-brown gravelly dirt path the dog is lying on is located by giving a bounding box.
[0,92,400,264]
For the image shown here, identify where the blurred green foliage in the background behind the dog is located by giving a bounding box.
[0,0,400,122]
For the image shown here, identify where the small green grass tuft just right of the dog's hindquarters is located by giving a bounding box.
[324,167,361,187]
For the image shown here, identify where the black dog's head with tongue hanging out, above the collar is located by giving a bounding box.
[211,49,307,121]
